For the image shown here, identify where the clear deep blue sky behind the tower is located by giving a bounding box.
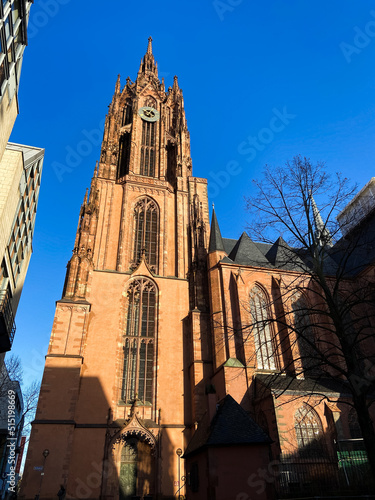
[7,0,375,381]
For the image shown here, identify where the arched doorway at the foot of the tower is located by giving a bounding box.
[119,437,155,500]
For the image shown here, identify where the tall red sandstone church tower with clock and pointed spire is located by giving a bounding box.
[21,38,211,500]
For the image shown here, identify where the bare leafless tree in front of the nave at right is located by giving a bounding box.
[246,156,375,477]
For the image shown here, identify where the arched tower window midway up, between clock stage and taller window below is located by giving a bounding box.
[133,197,159,272]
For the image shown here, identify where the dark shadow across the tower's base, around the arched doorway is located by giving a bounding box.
[19,364,183,500]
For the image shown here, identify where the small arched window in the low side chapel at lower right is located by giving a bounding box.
[294,404,323,454]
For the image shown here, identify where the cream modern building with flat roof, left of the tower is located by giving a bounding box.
[0,143,44,353]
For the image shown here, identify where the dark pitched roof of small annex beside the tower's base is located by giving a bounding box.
[184,394,272,457]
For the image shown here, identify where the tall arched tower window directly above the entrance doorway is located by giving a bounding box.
[121,278,156,404]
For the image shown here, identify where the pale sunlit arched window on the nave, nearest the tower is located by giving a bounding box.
[250,286,276,370]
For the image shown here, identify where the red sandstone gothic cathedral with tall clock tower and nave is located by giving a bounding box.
[20,38,375,500]
